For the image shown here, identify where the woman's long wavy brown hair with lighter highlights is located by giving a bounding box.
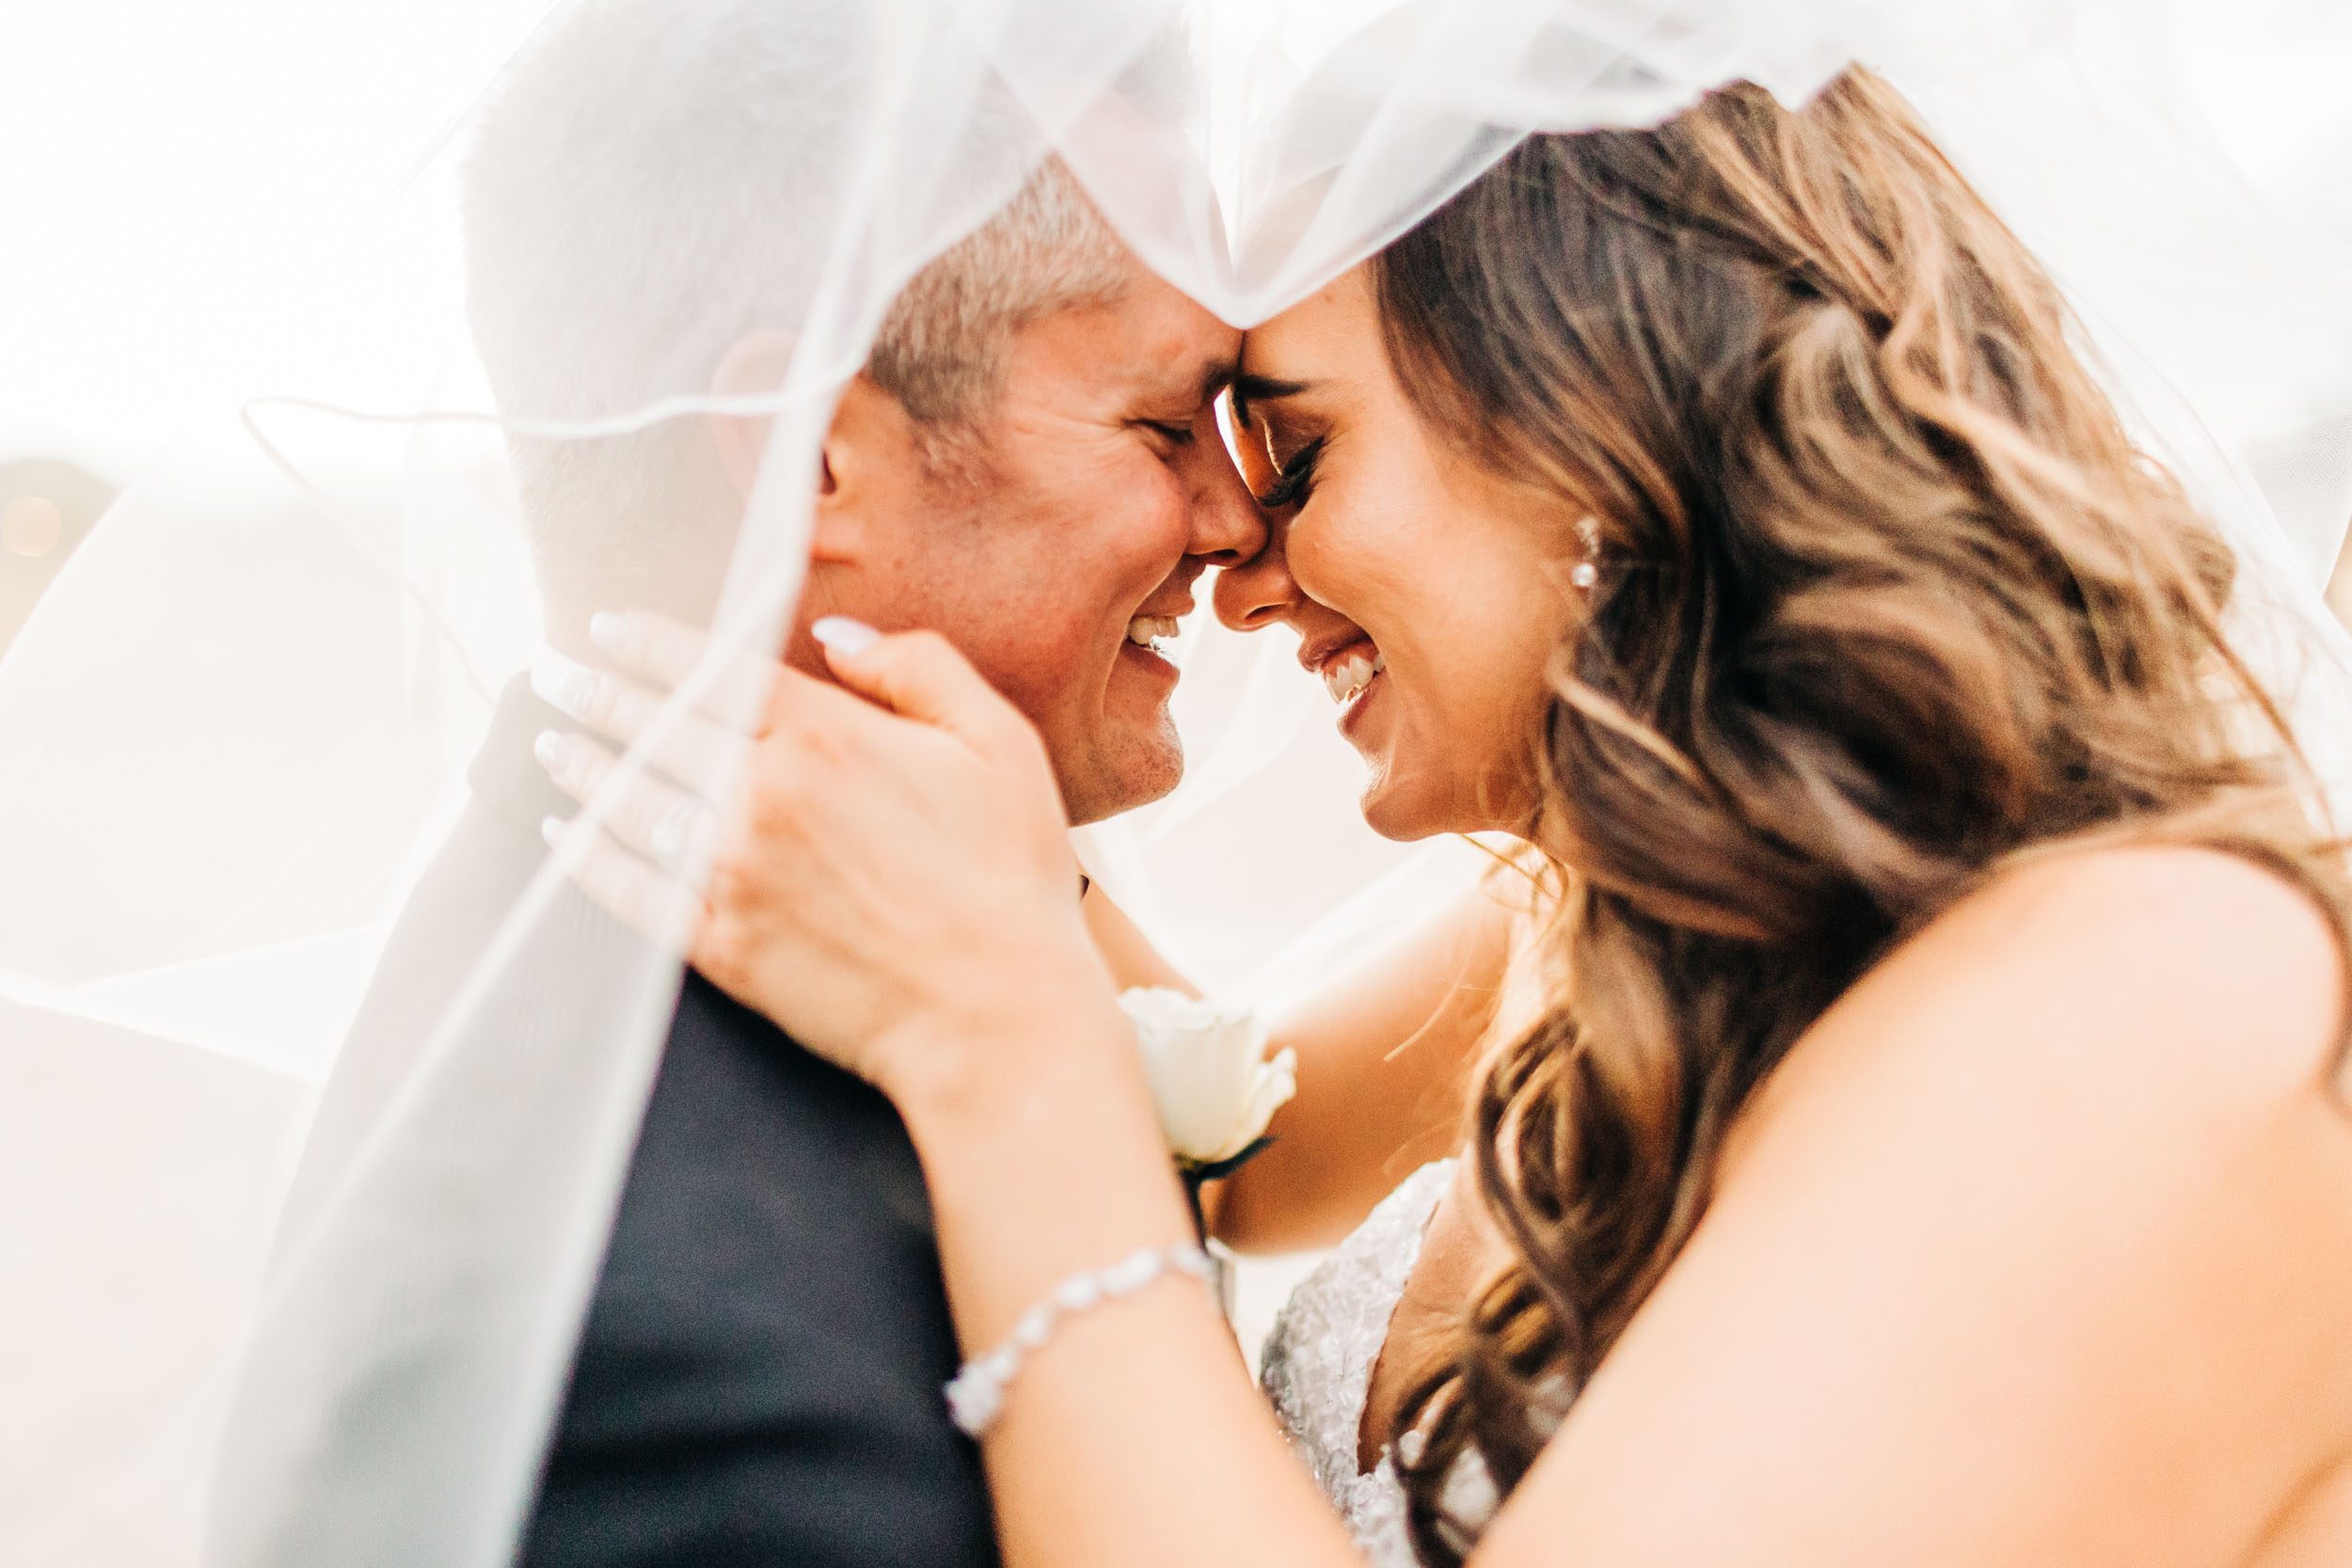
[1372,71,2345,1563]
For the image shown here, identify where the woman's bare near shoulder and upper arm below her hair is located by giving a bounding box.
[1496,848,2352,1563]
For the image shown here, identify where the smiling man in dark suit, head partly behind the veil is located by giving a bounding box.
[240,0,1263,1568]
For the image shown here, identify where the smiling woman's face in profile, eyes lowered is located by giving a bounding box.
[1216,268,1576,839]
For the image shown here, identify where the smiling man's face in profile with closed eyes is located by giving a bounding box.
[842,263,1265,823]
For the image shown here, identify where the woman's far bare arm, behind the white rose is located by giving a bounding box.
[1087,872,1529,1253]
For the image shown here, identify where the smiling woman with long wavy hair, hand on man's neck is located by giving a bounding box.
[541,68,2352,1568]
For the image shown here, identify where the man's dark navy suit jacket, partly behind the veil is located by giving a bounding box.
[331,682,997,1568]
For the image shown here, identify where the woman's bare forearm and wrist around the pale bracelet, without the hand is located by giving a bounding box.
[894,991,1362,1568]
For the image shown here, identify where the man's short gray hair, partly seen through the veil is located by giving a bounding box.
[459,0,1132,582]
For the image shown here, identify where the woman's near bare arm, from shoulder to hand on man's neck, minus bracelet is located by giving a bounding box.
[541,620,2352,1568]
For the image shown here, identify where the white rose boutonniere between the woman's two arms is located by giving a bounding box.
[1120,988,1298,1180]
